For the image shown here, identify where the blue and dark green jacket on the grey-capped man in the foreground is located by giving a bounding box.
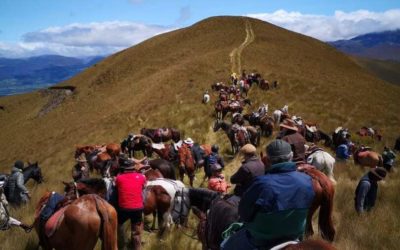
[239,162,315,242]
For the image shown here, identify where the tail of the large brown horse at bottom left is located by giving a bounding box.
[93,195,118,250]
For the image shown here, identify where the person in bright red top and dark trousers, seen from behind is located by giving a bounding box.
[115,158,146,249]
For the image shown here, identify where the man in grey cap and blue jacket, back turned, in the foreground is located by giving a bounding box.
[221,140,314,250]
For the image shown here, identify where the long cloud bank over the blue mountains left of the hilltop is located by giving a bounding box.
[0,21,173,57]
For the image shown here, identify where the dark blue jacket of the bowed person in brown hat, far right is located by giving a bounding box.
[355,172,378,213]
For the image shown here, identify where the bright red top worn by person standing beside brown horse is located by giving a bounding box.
[115,172,146,209]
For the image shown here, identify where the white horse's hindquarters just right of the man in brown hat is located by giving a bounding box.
[305,145,336,185]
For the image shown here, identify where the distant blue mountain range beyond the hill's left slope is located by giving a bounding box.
[0,55,104,96]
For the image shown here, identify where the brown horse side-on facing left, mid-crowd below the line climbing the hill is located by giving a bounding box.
[213,120,260,154]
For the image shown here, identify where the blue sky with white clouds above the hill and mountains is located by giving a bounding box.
[0,0,400,58]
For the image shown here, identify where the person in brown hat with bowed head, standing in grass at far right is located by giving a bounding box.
[354,167,387,214]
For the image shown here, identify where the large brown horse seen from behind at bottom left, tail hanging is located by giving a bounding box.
[34,192,118,250]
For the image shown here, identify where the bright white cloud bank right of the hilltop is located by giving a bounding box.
[247,9,400,41]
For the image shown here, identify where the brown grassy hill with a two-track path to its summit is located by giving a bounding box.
[0,17,400,249]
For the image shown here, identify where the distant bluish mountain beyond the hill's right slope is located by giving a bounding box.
[329,30,400,61]
